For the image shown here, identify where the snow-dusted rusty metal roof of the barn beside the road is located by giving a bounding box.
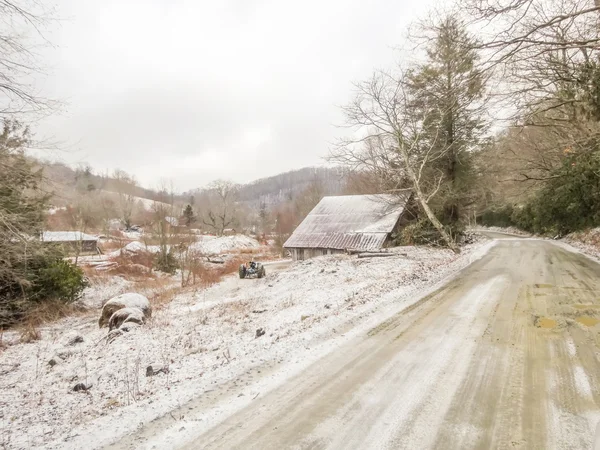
[284,191,411,250]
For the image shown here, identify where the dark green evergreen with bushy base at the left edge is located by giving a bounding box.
[0,120,85,328]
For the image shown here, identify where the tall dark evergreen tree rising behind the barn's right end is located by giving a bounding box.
[408,17,486,222]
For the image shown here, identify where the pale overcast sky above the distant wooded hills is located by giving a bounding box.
[38,0,432,190]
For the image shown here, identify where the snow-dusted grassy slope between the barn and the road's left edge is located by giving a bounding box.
[0,238,492,449]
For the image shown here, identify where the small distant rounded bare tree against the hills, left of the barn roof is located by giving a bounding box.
[202,180,239,236]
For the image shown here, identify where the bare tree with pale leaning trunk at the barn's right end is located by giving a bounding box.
[331,70,460,253]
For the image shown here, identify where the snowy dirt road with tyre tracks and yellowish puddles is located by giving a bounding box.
[175,239,600,449]
